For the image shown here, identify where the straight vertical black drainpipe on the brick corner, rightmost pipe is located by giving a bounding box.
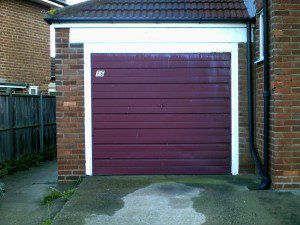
[260,0,271,190]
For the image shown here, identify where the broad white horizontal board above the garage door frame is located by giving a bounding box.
[70,27,247,43]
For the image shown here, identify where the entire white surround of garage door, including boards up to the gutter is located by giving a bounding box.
[54,24,246,175]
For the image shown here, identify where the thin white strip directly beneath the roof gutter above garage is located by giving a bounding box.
[53,23,246,28]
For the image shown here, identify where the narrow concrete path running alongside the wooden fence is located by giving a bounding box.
[0,161,65,225]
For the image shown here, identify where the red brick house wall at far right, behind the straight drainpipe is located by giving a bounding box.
[256,0,300,188]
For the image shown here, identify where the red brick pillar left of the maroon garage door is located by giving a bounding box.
[55,29,85,182]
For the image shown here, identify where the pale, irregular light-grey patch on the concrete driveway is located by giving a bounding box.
[85,182,205,225]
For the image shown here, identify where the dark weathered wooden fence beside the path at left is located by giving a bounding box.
[0,94,56,164]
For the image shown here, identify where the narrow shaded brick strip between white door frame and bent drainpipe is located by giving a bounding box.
[239,43,255,173]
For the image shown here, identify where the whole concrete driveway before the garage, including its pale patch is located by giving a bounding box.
[53,176,300,225]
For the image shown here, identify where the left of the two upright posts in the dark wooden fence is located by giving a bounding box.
[8,92,17,160]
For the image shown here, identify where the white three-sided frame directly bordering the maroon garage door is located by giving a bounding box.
[84,43,239,175]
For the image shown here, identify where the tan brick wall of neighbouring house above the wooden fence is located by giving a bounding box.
[0,0,50,92]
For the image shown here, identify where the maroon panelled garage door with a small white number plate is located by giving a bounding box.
[92,53,231,175]
